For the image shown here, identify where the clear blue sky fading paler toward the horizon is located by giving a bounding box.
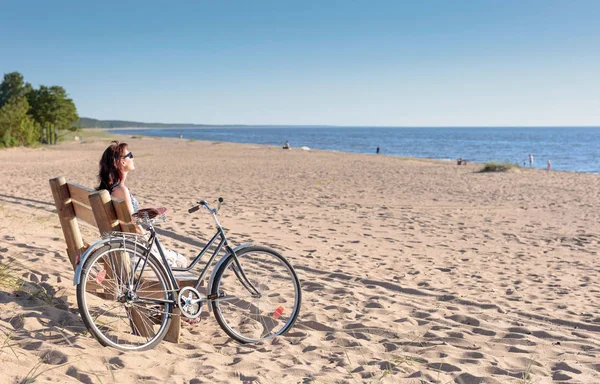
[0,0,600,126]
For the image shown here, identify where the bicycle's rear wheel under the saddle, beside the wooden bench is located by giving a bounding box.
[77,240,173,351]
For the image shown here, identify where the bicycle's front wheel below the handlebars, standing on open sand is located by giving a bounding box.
[212,246,302,344]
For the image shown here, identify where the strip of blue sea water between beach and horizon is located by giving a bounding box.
[110,126,600,173]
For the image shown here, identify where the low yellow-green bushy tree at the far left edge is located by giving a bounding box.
[0,97,39,147]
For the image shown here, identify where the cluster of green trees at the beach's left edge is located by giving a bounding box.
[0,72,79,147]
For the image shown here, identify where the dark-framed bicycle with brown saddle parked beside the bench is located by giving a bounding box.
[74,198,302,351]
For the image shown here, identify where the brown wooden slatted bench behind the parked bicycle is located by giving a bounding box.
[50,176,197,343]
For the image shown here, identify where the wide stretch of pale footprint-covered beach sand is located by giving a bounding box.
[0,136,600,384]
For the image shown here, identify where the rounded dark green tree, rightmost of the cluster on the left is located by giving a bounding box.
[28,85,79,144]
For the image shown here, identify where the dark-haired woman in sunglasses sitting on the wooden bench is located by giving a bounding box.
[96,141,187,267]
